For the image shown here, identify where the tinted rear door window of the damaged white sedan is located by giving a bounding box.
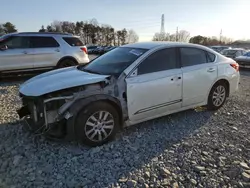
[180,48,208,67]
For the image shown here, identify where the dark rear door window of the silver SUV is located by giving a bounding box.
[30,37,59,48]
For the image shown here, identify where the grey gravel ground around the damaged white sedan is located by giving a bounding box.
[0,72,250,188]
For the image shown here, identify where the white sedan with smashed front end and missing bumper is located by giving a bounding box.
[18,42,240,146]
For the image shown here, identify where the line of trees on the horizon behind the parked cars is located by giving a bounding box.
[0,19,246,46]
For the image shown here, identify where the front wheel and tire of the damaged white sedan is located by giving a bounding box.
[75,101,120,146]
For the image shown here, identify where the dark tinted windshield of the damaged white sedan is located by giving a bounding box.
[79,47,147,76]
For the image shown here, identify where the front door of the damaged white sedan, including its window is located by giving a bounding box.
[126,48,182,122]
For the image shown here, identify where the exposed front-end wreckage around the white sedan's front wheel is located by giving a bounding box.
[19,77,128,140]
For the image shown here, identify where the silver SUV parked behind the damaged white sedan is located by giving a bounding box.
[0,32,89,74]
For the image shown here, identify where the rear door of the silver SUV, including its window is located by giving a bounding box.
[30,36,61,68]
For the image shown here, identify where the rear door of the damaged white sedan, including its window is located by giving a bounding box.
[180,47,217,107]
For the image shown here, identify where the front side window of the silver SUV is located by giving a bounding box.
[3,36,29,49]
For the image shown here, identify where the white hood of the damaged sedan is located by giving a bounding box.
[19,67,109,96]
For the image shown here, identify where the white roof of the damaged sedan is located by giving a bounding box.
[122,41,211,50]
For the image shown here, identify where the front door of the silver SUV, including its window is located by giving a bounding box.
[0,36,33,71]
